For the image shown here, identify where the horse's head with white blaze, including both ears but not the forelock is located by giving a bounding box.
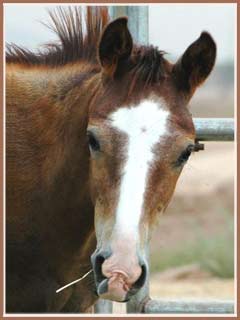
[87,18,216,301]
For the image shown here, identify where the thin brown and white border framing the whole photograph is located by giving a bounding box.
[0,0,240,320]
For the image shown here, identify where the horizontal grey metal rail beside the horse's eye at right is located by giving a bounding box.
[193,118,234,141]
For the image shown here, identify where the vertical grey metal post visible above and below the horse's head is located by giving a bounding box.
[94,6,149,313]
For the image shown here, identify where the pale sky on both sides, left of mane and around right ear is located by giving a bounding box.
[4,4,236,63]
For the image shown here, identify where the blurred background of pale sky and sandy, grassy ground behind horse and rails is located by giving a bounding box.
[4,4,236,310]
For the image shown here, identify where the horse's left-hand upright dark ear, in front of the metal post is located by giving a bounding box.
[98,17,133,77]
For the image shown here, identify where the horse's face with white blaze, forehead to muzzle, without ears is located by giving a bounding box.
[88,97,194,301]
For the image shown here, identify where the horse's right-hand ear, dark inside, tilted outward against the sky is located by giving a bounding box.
[173,32,217,94]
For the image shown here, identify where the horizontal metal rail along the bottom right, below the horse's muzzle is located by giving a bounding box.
[144,300,234,314]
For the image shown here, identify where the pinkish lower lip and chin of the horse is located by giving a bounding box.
[97,276,129,302]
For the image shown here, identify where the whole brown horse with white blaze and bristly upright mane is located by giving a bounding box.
[6,7,216,312]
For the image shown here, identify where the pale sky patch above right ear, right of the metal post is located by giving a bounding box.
[149,4,236,63]
